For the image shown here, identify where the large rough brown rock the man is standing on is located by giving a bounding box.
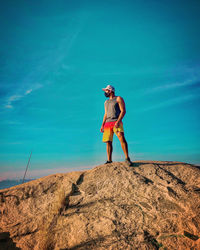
[0,161,200,250]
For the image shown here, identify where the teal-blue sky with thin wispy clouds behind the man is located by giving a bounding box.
[0,0,200,178]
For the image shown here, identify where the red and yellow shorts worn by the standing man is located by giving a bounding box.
[102,121,124,142]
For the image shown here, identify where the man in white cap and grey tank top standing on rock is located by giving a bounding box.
[100,85,132,166]
